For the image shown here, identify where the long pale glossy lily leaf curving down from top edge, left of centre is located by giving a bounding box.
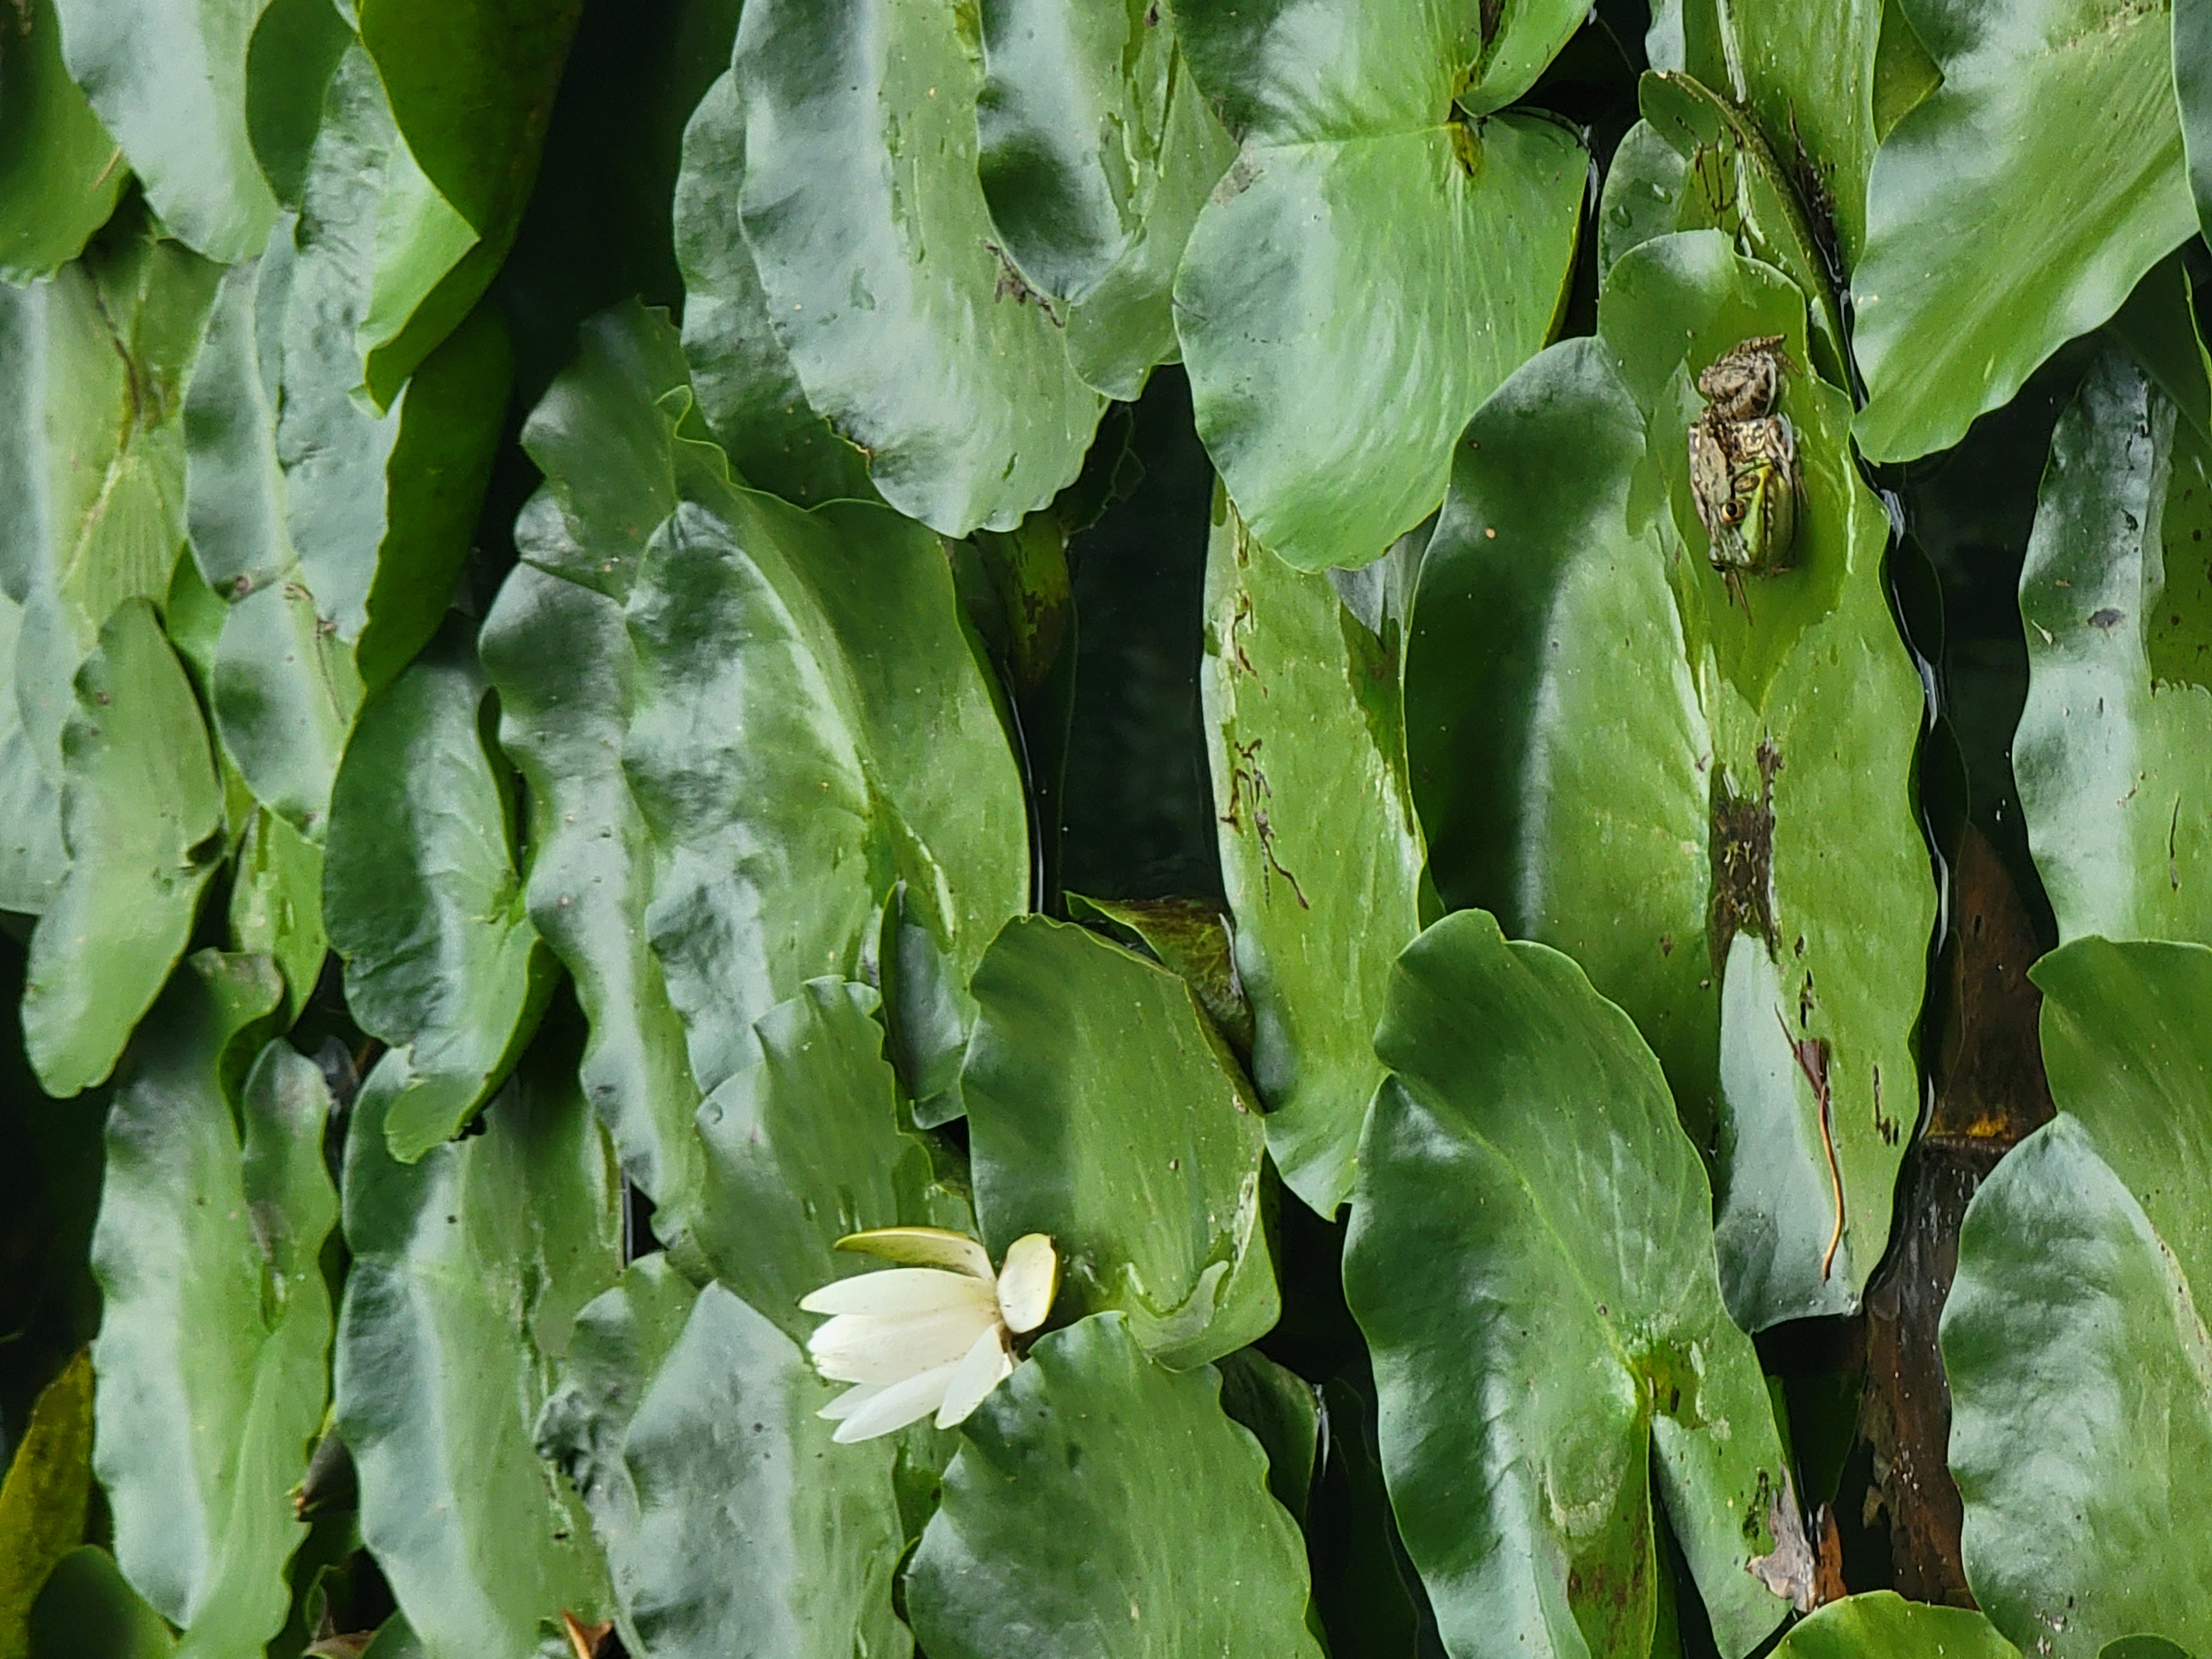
[721,0,1104,535]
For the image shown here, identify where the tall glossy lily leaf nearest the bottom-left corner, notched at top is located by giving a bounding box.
[93,953,338,1655]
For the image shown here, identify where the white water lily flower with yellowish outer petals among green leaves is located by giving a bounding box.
[799,1228,1060,1442]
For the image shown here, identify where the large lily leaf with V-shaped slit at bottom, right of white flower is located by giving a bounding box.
[1345,911,1803,1659]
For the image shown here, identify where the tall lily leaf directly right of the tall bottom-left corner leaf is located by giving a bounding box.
[334,1044,622,1659]
